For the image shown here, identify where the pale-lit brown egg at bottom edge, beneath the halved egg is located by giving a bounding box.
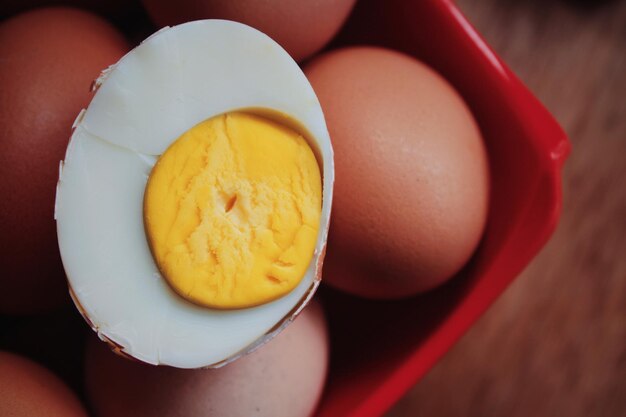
[86,303,328,417]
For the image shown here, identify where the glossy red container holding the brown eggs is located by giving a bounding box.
[316,0,570,417]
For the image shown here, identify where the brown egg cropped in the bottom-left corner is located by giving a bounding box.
[0,351,87,417]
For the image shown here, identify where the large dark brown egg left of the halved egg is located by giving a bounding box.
[0,8,127,313]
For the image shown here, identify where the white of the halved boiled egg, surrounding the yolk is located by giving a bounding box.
[55,20,334,368]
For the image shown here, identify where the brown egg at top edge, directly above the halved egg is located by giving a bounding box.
[143,0,356,61]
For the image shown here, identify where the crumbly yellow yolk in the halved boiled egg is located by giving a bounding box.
[144,112,322,309]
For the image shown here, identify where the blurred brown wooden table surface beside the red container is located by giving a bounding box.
[387,0,626,417]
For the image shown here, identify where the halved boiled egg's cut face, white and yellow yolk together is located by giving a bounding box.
[55,20,334,368]
